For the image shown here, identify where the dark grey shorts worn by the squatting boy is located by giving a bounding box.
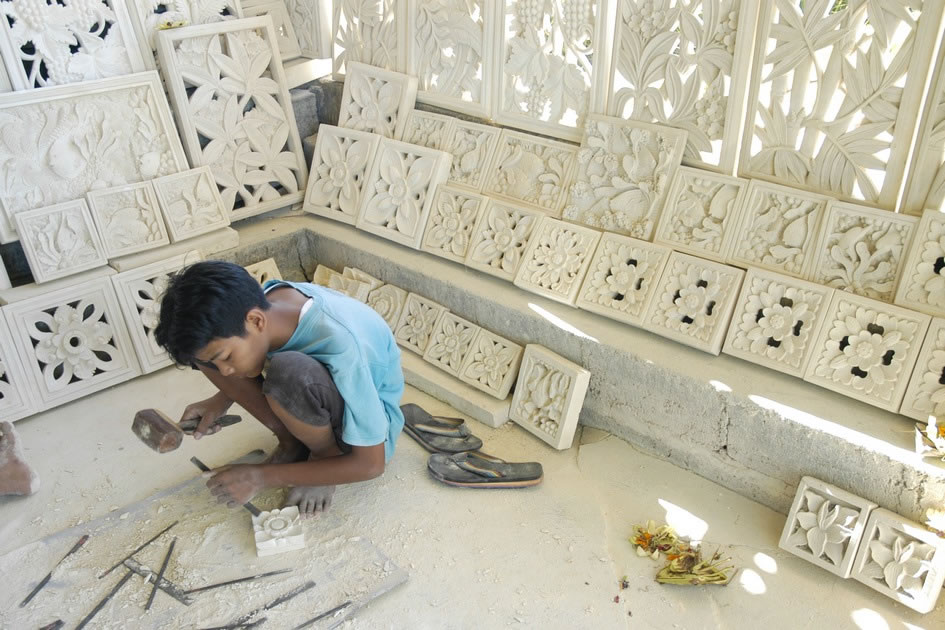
[263,352,351,453]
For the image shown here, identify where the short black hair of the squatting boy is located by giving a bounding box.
[154,260,269,365]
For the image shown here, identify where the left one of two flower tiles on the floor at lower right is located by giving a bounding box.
[778,477,876,578]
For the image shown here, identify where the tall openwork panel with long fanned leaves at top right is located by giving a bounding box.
[740,0,942,209]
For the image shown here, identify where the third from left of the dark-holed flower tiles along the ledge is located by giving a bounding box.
[722,269,833,378]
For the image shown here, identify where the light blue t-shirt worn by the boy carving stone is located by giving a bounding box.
[263,280,404,461]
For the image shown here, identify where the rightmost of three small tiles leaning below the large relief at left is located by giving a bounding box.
[152,166,230,243]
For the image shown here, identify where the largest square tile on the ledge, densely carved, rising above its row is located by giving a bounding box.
[563,115,686,241]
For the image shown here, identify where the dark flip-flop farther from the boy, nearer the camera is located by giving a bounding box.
[427,453,544,488]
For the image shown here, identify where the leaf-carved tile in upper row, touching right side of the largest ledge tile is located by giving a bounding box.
[654,166,748,262]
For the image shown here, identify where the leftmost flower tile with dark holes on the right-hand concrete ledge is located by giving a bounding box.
[575,232,672,326]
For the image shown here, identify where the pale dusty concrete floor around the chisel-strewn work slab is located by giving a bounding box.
[0,369,945,630]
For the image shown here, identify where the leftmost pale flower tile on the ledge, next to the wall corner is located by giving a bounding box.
[302,125,381,225]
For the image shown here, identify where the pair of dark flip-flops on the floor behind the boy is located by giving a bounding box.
[401,404,544,488]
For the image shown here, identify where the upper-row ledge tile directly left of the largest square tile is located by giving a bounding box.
[483,129,578,216]
